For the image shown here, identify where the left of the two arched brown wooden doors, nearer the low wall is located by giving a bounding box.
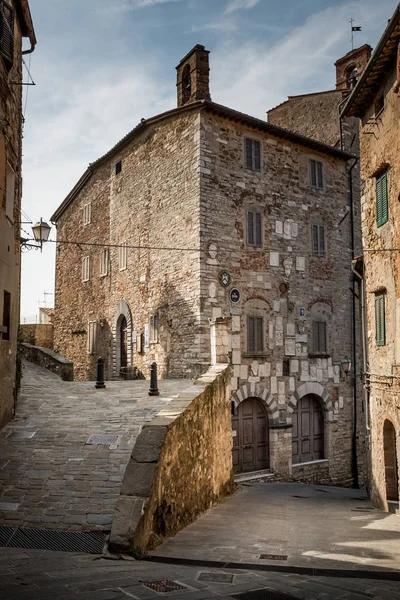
[232,398,269,473]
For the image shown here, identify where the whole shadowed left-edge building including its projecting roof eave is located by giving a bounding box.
[0,0,36,427]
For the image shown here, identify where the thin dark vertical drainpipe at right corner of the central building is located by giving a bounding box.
[349,158,359,488]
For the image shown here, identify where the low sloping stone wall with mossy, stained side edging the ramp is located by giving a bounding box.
[109,365,234,555]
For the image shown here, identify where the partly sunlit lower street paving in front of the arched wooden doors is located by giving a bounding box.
[152,483,400,576]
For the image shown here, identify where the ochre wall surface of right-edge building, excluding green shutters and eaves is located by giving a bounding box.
[360,61,400,509]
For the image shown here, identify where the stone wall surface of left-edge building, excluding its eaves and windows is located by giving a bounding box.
[0,0,22,427]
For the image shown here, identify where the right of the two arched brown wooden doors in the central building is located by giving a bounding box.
[292,394,324,465]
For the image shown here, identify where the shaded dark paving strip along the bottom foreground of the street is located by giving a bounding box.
[0,548,400,600]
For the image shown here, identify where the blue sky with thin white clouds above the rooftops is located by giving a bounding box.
[21,0,397,322]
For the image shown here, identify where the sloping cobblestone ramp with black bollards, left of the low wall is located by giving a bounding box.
[0,362,191,530]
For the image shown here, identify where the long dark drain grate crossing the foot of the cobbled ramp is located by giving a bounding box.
[0,525,106,554]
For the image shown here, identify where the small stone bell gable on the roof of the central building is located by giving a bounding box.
[176,44,211,107]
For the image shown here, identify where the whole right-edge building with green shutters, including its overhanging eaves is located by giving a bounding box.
[342,6,400,510]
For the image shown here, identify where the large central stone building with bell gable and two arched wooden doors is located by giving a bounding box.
[52,46,362,484]
